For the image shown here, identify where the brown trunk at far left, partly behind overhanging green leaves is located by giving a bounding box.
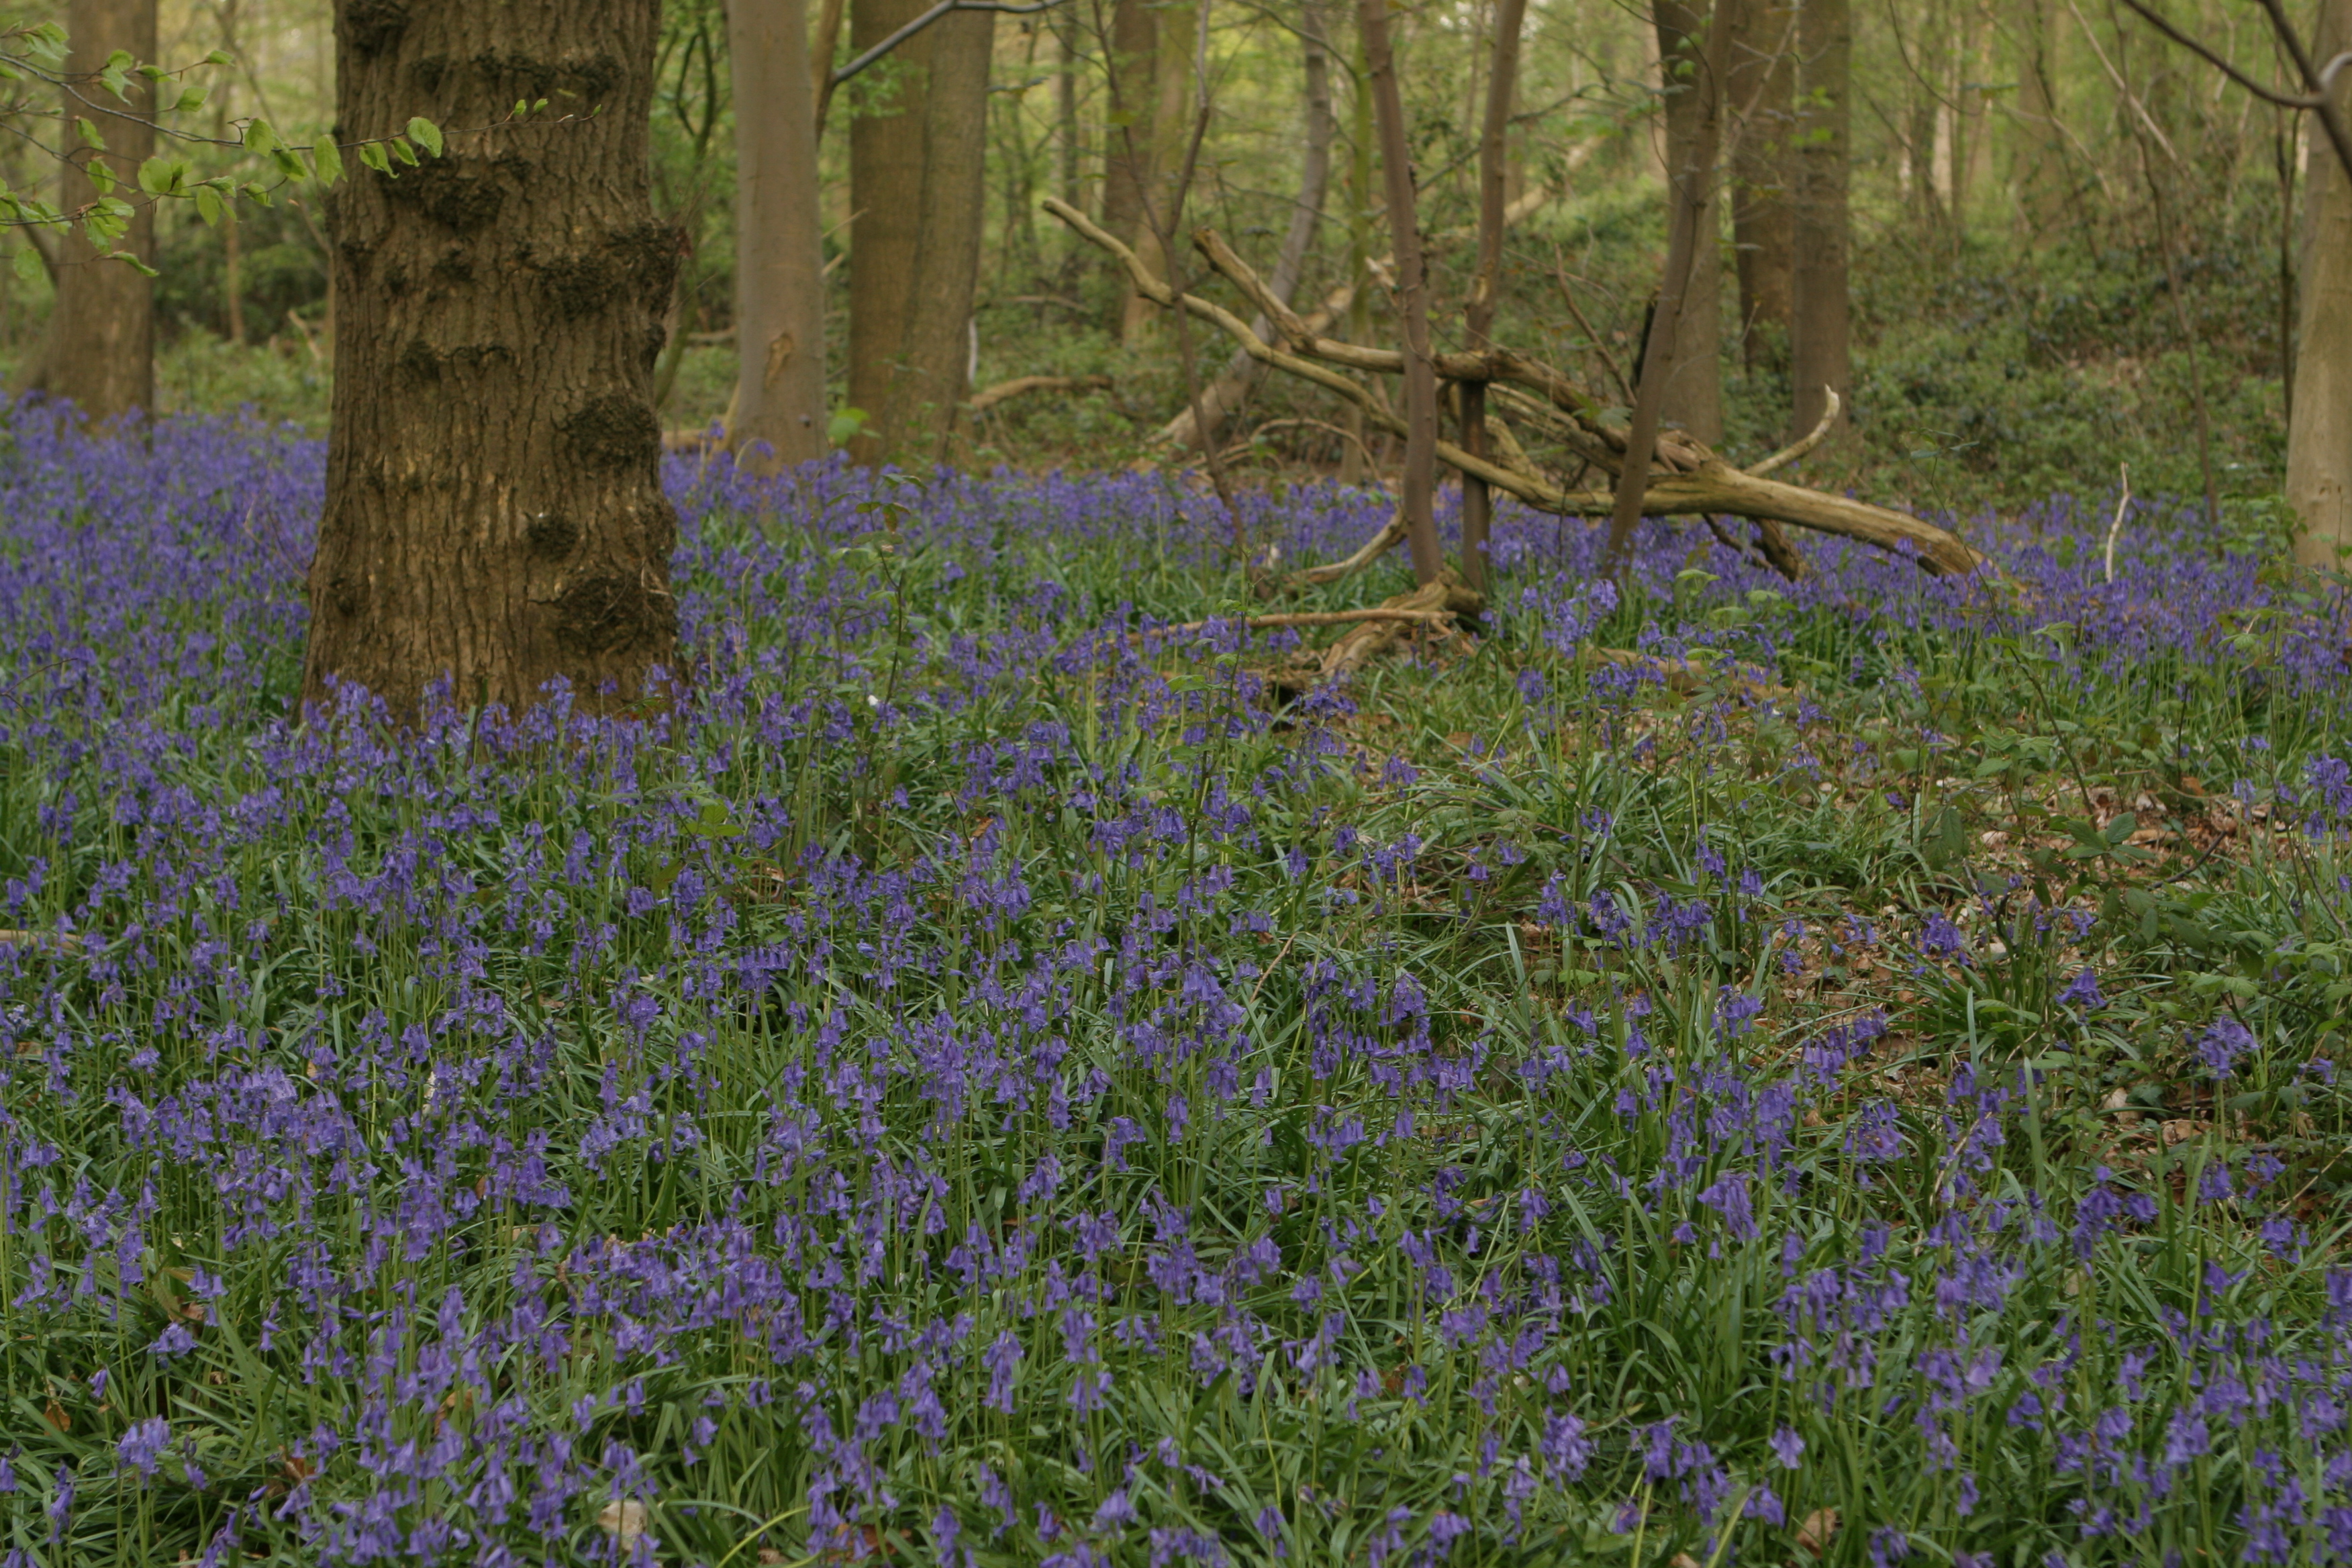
[28,0,155,421]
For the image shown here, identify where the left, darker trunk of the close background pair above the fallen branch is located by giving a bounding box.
[1724,0,1797,369]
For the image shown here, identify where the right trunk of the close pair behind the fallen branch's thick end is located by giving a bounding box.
[1790,0,1853,440]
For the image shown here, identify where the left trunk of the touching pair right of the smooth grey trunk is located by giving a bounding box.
[849,0,943,468]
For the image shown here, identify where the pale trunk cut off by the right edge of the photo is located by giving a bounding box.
[2286,0,2352,567]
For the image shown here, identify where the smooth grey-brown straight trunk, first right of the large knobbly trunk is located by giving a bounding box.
[727,0,826,473]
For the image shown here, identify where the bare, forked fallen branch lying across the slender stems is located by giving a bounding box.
[1044,197,1985,574]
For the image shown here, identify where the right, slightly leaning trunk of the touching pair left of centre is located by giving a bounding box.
[882,12,997,468]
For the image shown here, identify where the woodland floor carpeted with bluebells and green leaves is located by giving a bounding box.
[0,413,2352,1568]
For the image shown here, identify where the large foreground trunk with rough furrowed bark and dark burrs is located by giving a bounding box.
[303,0,680,717]
